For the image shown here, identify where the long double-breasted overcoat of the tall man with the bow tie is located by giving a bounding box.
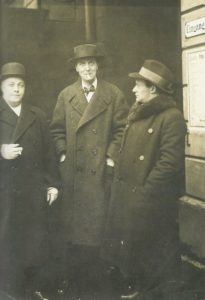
[51,80,127,245]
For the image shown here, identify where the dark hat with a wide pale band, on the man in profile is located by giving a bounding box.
[129,59,174,94]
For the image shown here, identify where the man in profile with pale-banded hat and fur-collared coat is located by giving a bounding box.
[102,60,186,299]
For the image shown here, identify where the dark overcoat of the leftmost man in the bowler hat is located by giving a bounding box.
[0,99,59,266]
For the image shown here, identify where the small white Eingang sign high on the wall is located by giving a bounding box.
[185,17,205,38]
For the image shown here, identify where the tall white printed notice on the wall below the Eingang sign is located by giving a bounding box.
[187,47,205,127]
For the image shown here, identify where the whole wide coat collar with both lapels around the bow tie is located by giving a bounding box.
[69,80,110,130]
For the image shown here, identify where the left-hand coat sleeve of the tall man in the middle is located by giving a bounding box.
[50,93,66,157]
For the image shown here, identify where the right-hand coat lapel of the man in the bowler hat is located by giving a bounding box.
[12,104,36,143]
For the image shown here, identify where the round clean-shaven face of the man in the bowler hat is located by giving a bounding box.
[1,77,25,107]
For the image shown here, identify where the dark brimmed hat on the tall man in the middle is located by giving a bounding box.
[68,44,104,63]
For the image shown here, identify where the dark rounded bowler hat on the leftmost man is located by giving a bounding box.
[0,62,26,80]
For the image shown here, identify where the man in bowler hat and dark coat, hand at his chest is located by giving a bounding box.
[0,62,59,299]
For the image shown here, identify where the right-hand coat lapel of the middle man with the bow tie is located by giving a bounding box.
[77,82,108,130]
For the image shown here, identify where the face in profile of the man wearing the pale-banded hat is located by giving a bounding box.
[132,79,153,103]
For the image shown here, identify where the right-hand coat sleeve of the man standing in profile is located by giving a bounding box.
[144,110,186,195]
